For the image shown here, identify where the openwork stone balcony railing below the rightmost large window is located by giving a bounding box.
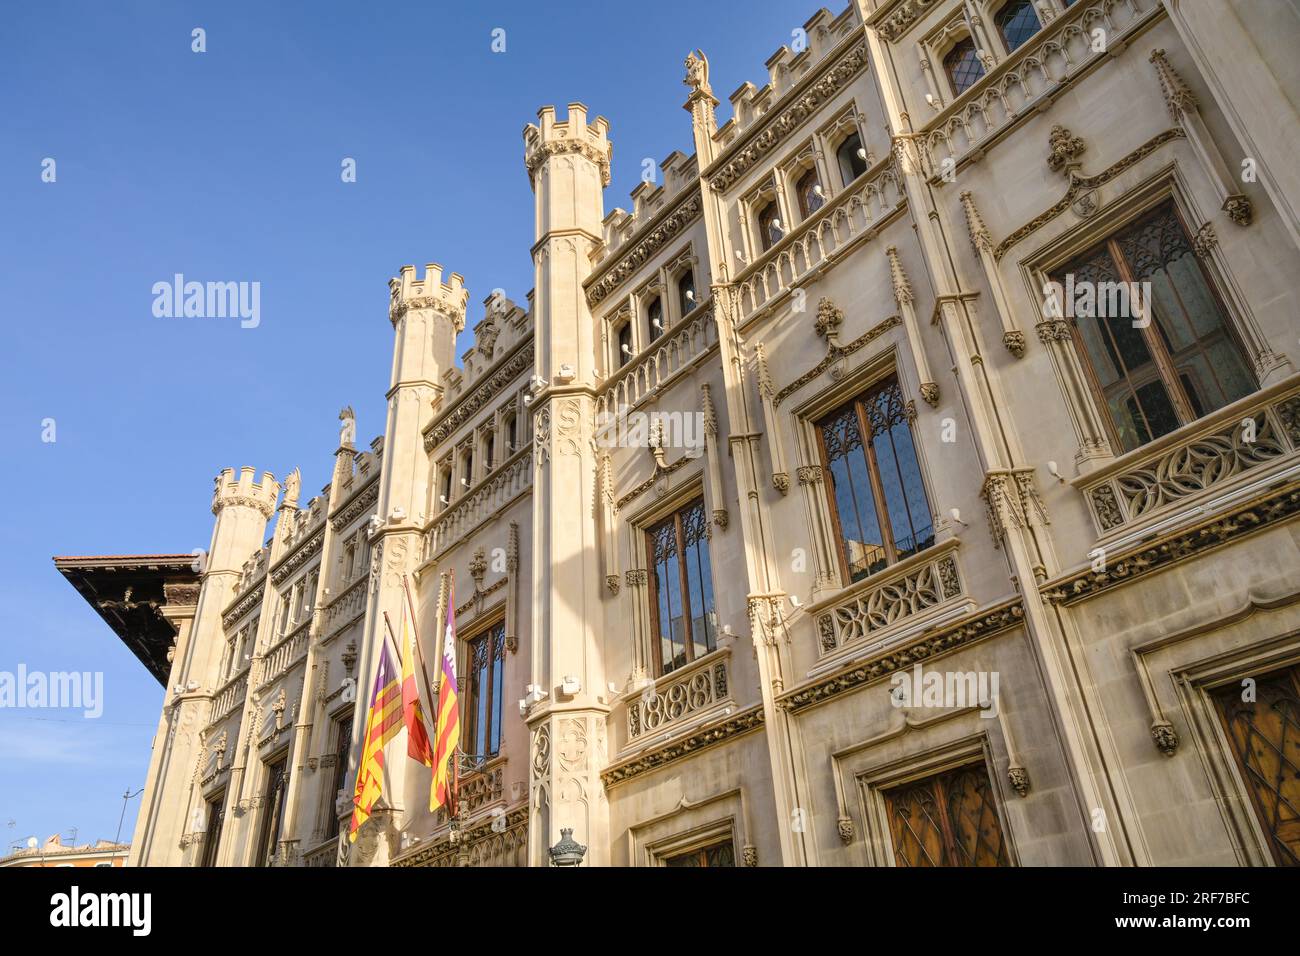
[1076,378,1300,537]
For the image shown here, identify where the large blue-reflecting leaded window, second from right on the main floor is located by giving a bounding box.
[816,376,935,581]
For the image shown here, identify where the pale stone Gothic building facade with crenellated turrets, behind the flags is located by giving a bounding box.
[86,0,1300,866]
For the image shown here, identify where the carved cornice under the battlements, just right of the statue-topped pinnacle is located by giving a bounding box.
[701,33,867,193]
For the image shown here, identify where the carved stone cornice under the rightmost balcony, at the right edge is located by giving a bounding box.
[1040,481,1300,605]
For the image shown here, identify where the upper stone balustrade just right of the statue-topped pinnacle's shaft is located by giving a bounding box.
[736,156,906,321]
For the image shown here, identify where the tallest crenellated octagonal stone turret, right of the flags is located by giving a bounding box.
[524,103,611,866]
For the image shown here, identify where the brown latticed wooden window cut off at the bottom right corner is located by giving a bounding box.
[1214,666,1300,866]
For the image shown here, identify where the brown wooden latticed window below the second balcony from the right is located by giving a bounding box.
[884,761,1011,866]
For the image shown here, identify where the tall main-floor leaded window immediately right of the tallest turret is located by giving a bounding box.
[646,498,718,674]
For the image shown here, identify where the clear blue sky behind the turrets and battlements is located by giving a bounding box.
[0,0,811,852]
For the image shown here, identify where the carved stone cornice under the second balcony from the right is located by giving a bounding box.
[776,598,1024,714]
